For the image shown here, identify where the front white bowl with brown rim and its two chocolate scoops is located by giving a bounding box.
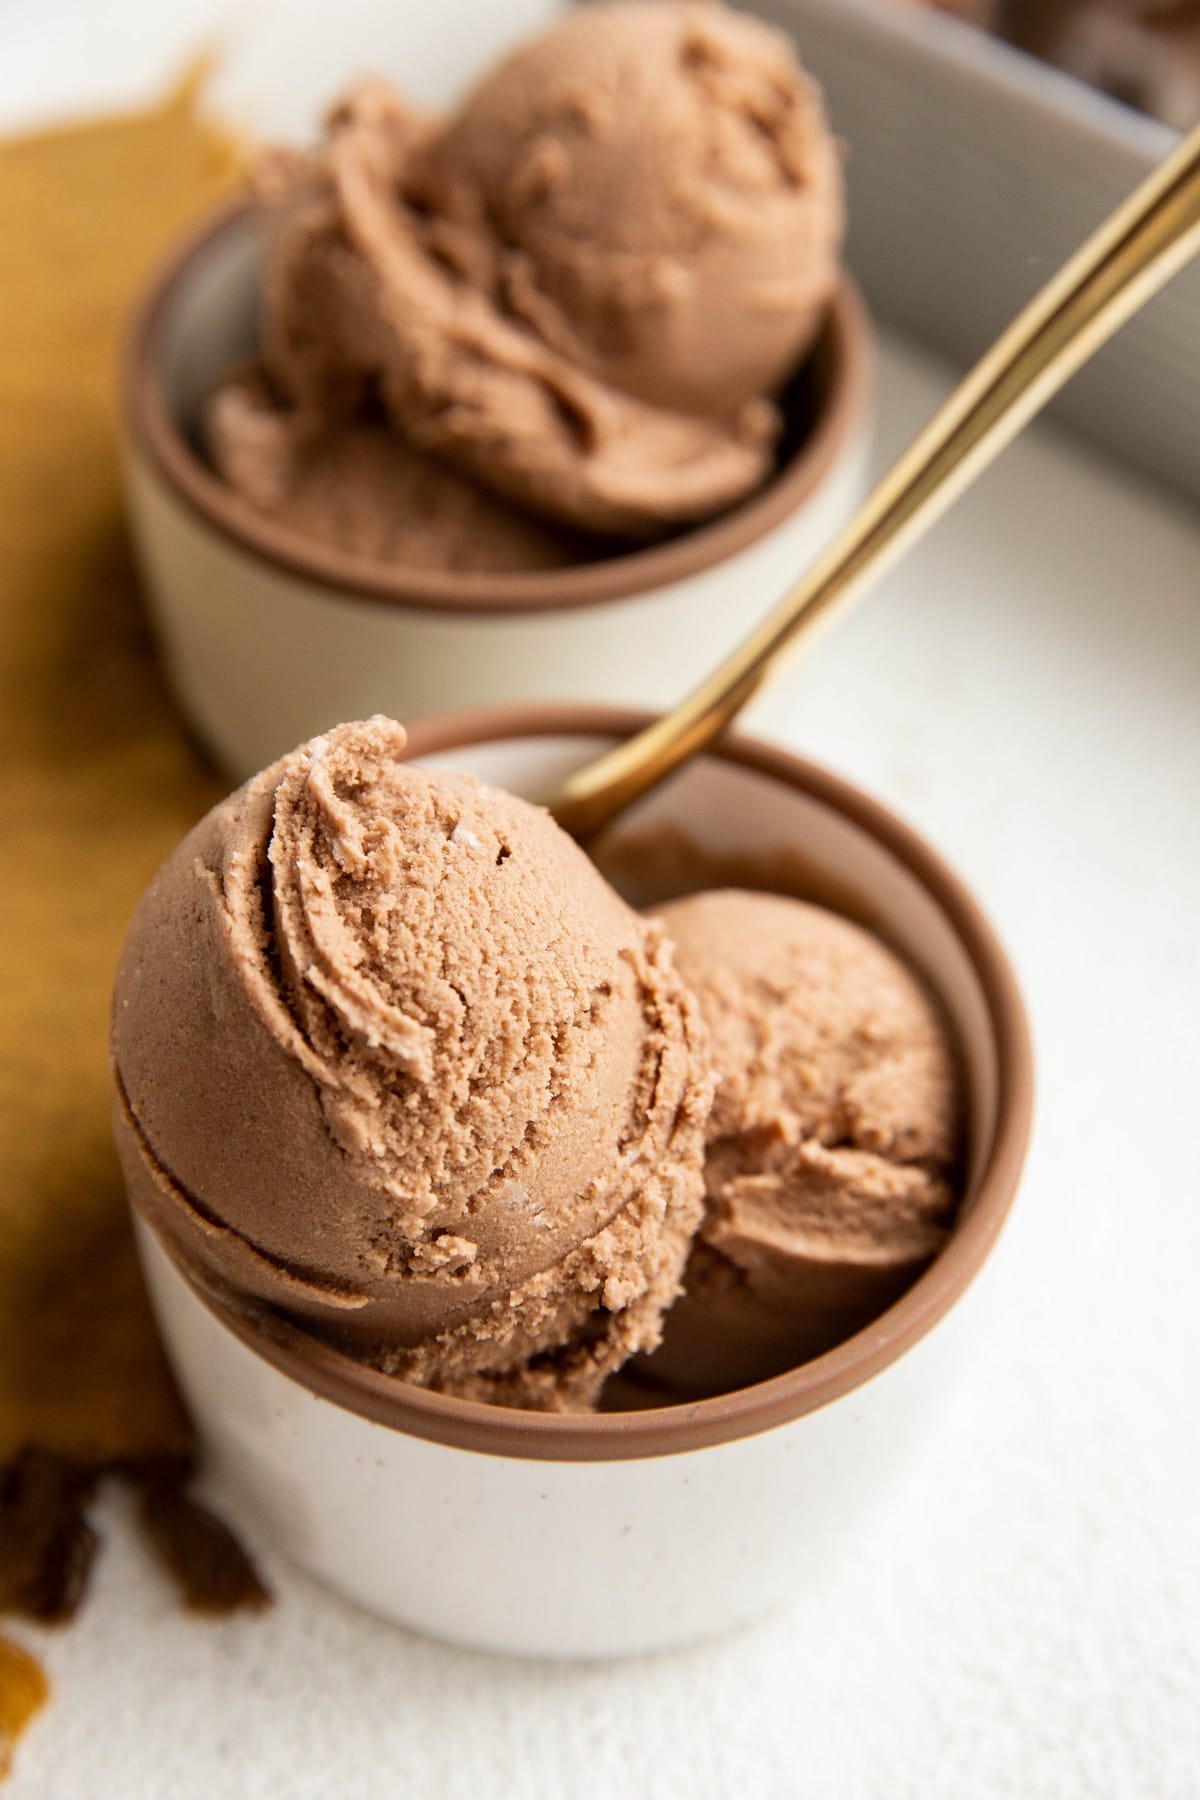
[113,707,1031,1656]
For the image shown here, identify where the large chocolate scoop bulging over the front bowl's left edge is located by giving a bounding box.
[112,718,711,1408]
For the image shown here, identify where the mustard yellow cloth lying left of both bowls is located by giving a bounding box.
[0,66,264,1768]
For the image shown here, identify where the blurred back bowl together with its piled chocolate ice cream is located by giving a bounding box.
[124,0,869,776]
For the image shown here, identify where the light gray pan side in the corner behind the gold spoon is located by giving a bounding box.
[754,0,1200,500]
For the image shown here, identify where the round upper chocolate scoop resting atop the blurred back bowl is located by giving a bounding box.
[414,0,844,419]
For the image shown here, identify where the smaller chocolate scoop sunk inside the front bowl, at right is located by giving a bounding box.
[649,889,961,1391]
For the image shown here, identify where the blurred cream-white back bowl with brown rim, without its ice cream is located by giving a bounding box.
[124,207,871,779]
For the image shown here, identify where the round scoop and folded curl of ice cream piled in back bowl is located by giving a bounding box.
[206,0,844,538]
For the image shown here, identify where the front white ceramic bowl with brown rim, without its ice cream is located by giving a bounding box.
[129,707,1031,1656]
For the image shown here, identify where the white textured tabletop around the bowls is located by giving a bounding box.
[0,0,1200,1800]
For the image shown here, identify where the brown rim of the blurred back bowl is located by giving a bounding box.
[121,202,871,614]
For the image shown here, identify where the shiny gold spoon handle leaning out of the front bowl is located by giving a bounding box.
[551,128,1200,841]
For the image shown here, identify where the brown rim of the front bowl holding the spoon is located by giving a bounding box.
[143,706,1033,1462]
